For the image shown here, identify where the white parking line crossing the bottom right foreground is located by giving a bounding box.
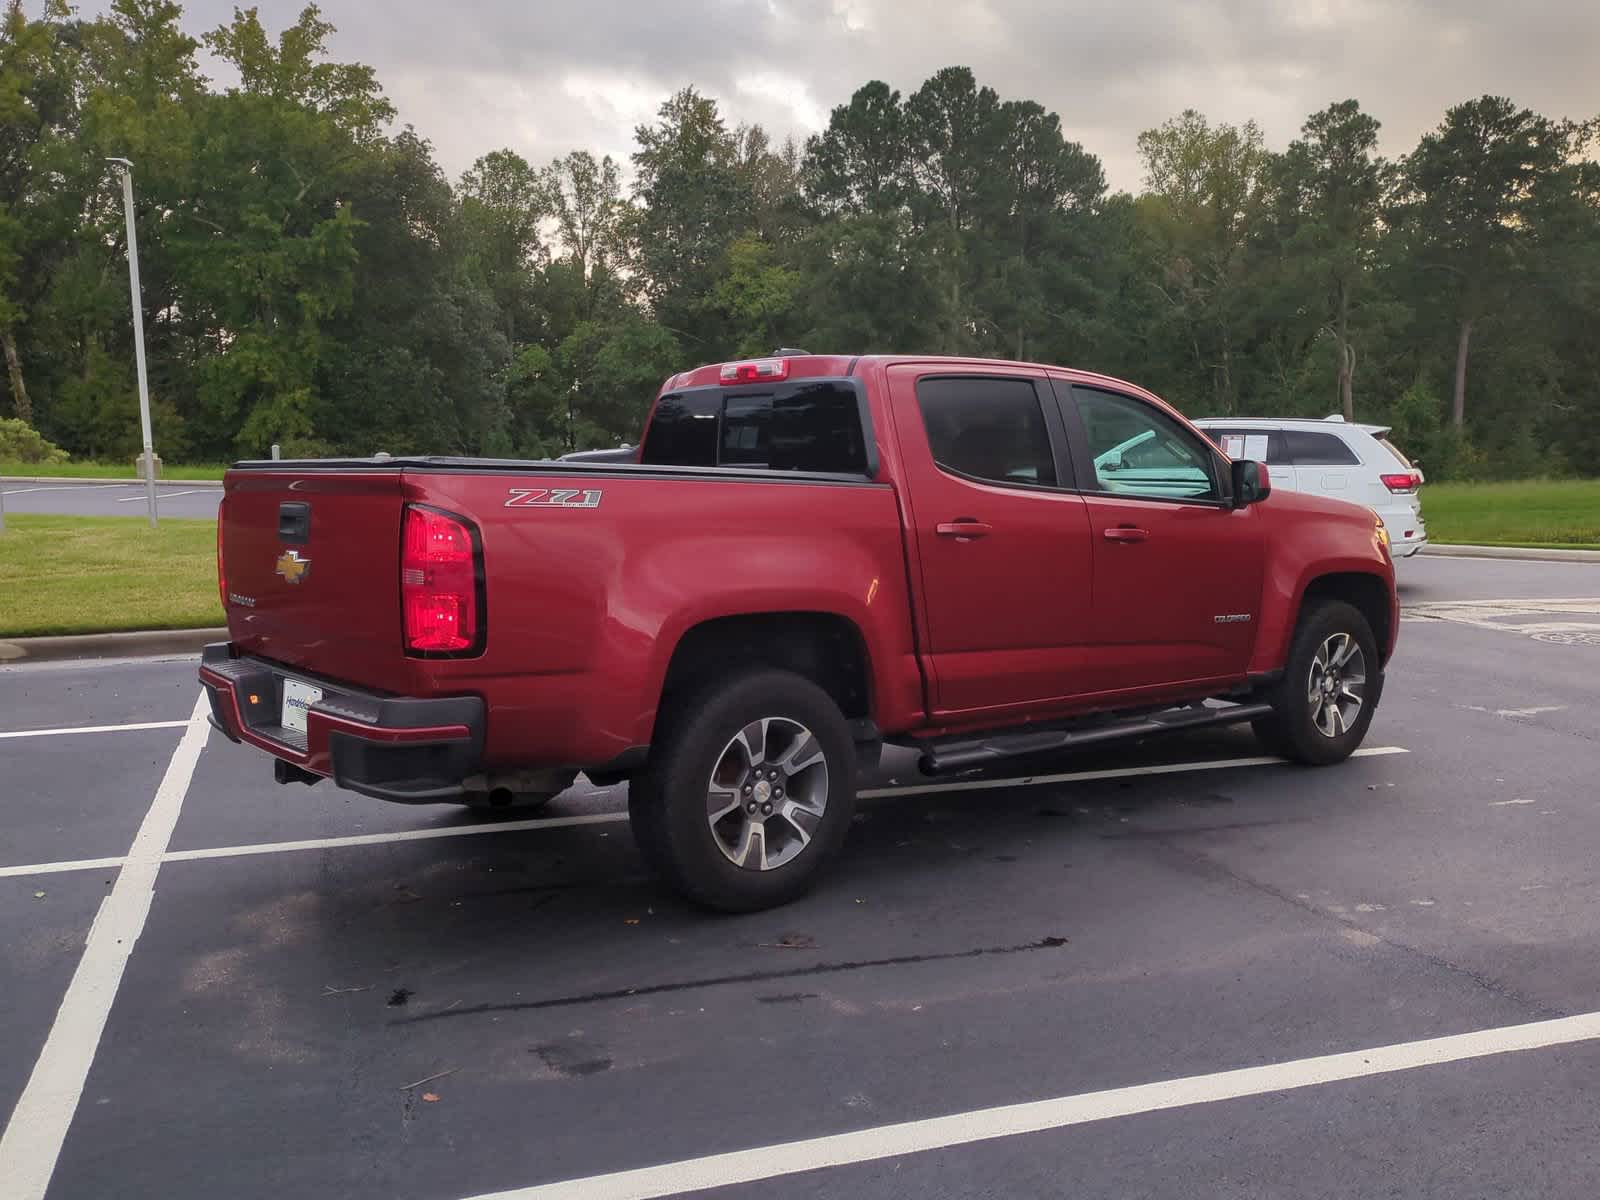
[457,1013,1600,1200]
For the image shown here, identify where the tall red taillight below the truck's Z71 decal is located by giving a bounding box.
[400,507,483,654]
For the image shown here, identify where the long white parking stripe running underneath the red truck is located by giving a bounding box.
[0,746,1410,878]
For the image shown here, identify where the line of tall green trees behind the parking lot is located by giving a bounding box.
[0,0,1600,477]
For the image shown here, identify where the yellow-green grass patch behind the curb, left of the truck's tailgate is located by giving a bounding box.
[0,515,222,637]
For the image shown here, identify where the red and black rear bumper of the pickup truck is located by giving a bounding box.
[200,642,485,803]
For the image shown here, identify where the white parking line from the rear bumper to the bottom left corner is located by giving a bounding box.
[0,693,211,1200]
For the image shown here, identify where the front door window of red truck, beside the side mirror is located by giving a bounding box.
[1072,387,1222,501]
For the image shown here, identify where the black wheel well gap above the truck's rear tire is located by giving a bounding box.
[656,613,872,730]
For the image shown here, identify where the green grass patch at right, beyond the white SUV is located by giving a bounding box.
[1422,480,1600,549]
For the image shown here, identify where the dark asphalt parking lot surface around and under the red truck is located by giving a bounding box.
[0,560,1600,1200]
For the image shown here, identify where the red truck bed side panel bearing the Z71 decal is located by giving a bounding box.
[405,469,923,765]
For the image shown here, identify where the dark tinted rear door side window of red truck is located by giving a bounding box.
[917,376,1056,486]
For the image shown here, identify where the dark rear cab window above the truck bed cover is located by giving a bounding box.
[643,379,867,475]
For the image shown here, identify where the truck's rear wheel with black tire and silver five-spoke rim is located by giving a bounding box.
[627,669,856,912]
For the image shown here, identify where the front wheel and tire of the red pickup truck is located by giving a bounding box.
[1253,600,1384,766]
